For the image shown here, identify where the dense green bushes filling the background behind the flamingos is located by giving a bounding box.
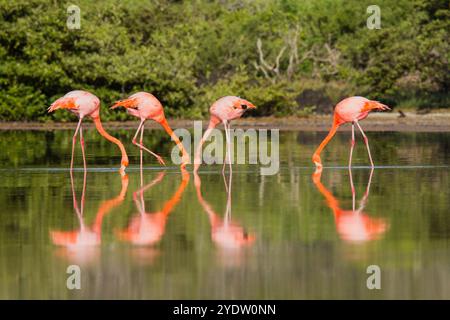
[0,0,450,121]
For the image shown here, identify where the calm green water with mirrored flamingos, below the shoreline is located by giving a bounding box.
[0,130,450,299]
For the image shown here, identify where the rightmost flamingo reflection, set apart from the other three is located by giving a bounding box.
[312,168,388,242]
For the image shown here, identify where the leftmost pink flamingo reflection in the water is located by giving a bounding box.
[50,170,128,261]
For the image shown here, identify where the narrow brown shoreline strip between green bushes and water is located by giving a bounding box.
[0,112,450,132]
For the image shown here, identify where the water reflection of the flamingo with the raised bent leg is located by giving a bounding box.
[116,167,189,245]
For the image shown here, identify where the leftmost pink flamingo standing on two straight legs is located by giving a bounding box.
[48,90,128,175]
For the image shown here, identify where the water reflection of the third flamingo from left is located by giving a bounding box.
[194,172,255,249]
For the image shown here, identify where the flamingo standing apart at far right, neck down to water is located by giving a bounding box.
[312,97,390,170]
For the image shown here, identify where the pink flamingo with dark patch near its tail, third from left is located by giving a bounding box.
[194,96,256,172]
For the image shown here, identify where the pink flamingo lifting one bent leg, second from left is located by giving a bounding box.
[111,92,190,168]
